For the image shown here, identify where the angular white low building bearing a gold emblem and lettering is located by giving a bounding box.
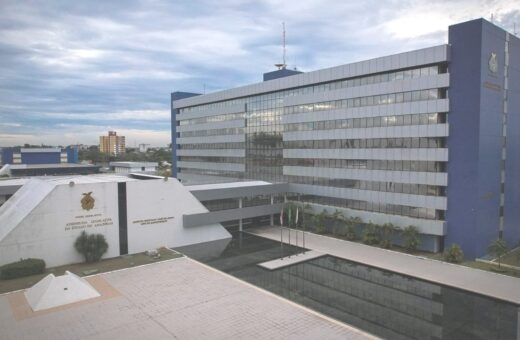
[0,175,231,267]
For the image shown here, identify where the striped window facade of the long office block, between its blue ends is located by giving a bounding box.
[176,63,448,220]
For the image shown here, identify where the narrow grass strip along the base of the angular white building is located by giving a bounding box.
[0,248,182,294]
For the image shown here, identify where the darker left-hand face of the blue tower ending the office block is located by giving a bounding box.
[444,21,482,255]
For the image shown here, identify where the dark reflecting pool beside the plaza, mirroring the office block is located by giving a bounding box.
[176,232,520,340]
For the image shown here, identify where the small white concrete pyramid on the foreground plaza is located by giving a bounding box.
[25,271,101,312]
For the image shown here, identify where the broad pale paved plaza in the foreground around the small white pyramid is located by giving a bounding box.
[0,257,372,340]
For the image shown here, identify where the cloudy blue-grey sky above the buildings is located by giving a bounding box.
[0,0,520,146]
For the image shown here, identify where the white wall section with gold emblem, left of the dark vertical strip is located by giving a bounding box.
[0,183,119,267]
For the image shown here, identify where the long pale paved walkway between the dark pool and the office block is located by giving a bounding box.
[247,227,520,304]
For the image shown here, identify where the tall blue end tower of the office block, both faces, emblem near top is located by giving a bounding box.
[445,19,520,258]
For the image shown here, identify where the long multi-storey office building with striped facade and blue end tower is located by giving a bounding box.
[171,19,520,258]
